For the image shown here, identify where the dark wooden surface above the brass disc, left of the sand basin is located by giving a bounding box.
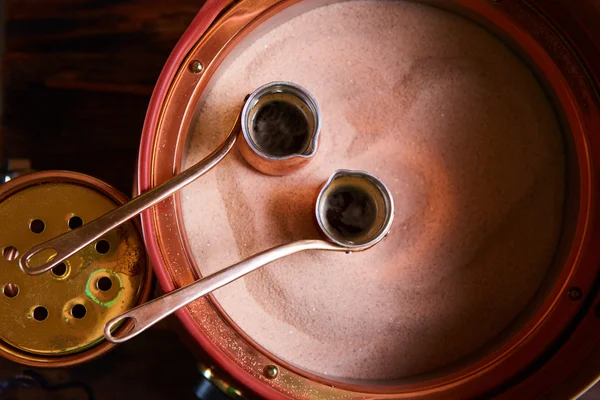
[0,0,203,195]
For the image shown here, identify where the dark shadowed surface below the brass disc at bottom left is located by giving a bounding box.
[0,329,201,400]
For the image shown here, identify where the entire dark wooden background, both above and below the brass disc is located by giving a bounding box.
[0,0,211,400]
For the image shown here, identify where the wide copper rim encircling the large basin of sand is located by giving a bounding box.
[138,0,600,398]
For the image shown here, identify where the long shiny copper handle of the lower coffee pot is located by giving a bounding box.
[104,240,348,343]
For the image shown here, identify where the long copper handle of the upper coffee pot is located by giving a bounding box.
[19,114,240,275]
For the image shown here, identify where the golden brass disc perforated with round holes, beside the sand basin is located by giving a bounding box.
[0,173,149,356]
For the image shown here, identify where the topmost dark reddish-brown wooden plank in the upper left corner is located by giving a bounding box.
[6,0,201,53]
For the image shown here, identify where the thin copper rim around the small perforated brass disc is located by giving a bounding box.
[0,171,152,367]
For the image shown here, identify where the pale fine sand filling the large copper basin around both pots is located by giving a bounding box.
[183,1,564,378]
